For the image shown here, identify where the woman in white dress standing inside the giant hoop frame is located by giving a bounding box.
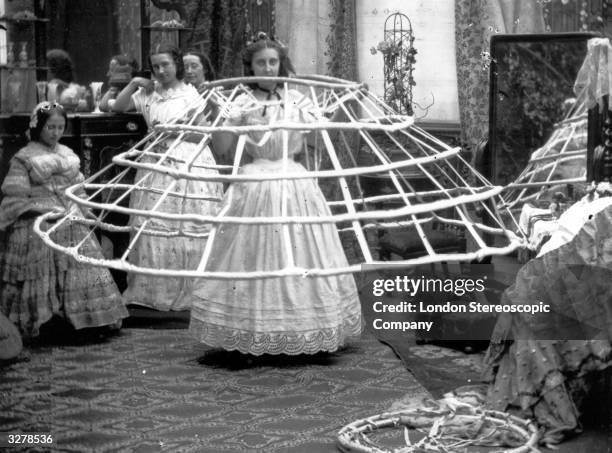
[190,34,361,355]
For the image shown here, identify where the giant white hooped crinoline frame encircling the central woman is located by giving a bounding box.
[34,76,521,279]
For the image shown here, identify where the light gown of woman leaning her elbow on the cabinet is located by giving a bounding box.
[123,83,223,311]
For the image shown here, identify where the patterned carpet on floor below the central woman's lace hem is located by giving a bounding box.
[0,329,427,453]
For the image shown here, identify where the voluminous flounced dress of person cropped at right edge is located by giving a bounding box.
[485,191,612,443]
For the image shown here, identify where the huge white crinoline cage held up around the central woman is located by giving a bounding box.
[35,76,521,279]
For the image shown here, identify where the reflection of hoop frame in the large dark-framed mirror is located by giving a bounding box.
[489,33,594,250]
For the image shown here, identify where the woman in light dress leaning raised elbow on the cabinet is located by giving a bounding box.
[113,47,222,311]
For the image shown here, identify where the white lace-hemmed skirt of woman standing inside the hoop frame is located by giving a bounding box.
[190,159,362,355]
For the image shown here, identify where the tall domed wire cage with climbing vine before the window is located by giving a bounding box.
[379,13,417,115]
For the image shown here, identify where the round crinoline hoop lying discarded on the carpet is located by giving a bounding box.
[336,405,539,453]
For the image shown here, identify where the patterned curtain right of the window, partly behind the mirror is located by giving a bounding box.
[455,0,545,151]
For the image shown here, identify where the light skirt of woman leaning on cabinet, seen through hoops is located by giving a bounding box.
[123,142,223,311]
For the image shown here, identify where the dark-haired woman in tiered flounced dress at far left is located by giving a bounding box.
[0,102,128,337]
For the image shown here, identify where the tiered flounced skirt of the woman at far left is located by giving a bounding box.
[0,216,128,337]
